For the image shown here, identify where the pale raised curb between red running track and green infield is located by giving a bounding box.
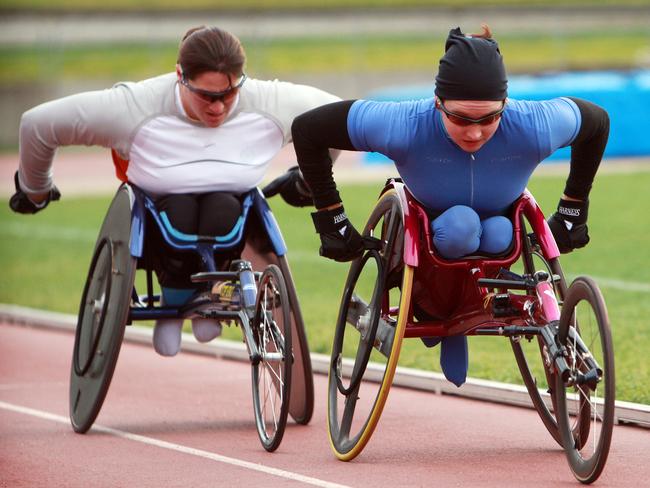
[0,303,650,428]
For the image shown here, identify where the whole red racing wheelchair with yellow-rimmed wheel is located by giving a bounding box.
[328,179,615,483]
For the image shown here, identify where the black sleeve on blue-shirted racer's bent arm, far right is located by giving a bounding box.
[564,97,609,200]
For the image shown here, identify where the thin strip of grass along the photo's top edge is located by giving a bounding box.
[0,0,647,11]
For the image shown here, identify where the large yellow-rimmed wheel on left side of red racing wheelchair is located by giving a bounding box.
[328,189,413,461]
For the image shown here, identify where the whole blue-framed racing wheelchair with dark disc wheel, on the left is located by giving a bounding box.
[70,177,314,451]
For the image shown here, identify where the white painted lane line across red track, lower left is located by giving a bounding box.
[0,401,348,488]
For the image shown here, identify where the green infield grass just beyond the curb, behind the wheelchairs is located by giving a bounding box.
[0,172,650,404]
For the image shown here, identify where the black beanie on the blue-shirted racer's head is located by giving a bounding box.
[435,27,508,100]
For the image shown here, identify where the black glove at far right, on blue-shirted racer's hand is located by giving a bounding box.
[548,199,589,254]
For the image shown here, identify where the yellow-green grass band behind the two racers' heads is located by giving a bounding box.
[0,29,650,87]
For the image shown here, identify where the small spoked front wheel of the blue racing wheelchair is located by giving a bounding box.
[252,264,293,451]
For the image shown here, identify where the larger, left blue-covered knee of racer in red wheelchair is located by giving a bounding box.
[431,205,481,259]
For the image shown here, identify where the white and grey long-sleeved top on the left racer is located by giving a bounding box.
[19,73,339,195]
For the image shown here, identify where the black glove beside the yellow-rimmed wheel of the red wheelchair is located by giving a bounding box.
[311,207,364,261]
